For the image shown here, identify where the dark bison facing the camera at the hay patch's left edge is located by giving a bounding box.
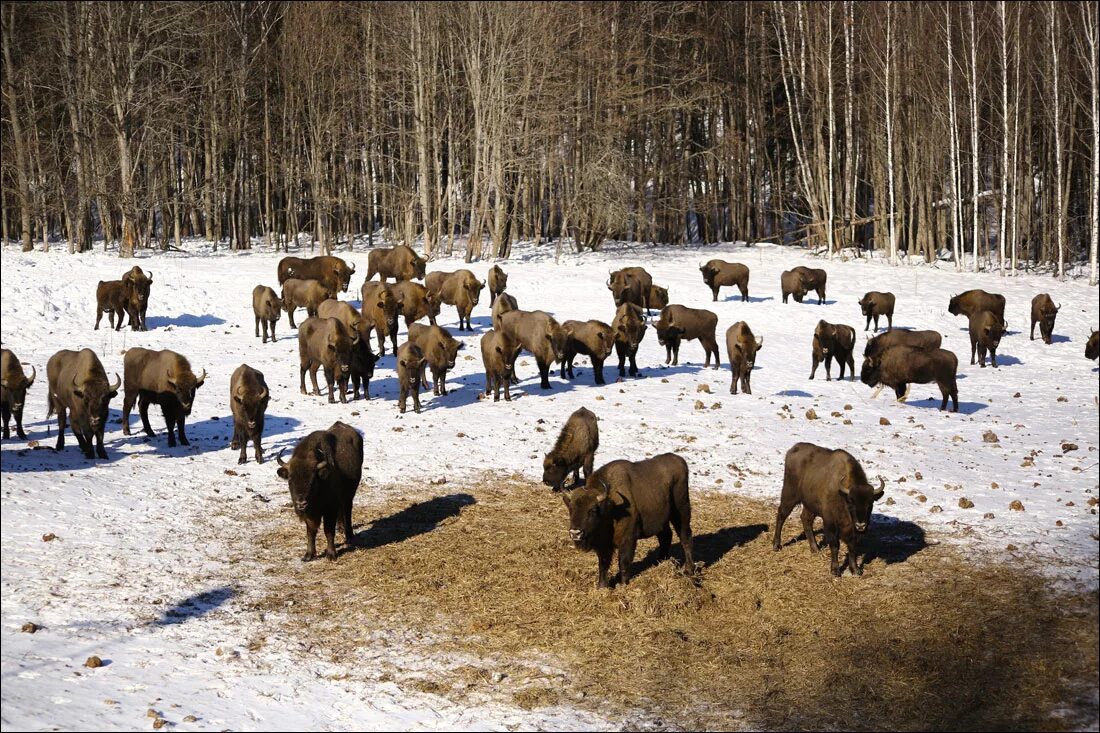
[276,422,363,562]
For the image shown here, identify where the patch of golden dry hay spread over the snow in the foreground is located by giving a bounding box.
[251,478,1098,730]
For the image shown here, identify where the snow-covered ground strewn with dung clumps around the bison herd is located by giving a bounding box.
[0,236,1100,730]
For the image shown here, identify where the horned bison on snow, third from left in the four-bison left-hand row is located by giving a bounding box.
[122,348,206,448]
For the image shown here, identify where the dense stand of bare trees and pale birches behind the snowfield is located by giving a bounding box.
[0,0,1100,283]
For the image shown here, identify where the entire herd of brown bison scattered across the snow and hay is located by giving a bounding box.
[0,245,1100,587]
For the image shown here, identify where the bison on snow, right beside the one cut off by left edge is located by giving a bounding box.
[46,349,122,458]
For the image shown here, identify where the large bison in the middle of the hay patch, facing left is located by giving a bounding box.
[562,453,695,588]
